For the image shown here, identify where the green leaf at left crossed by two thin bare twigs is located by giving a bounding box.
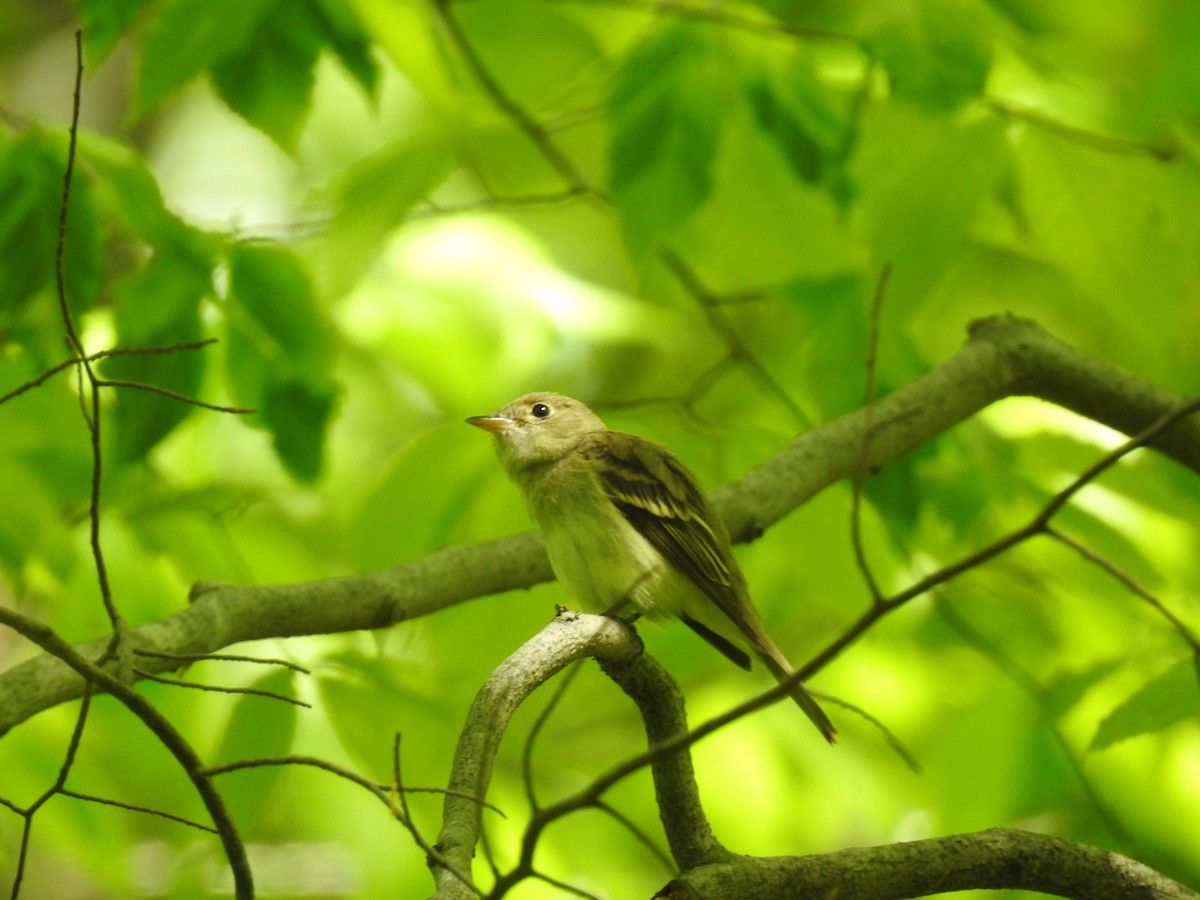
[102,252,211,462]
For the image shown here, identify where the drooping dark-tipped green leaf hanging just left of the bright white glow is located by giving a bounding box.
[227,245,336,481]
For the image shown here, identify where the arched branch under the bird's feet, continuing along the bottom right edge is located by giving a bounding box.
[430,613,1200,900]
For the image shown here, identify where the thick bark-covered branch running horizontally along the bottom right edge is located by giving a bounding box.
[660,828,1200,900]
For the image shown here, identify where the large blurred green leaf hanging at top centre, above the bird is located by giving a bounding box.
[608,25,731,258]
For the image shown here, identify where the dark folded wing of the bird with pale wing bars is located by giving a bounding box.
[580,431,754,668]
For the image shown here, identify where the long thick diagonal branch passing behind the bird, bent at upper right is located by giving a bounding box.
[0,317,1200,734]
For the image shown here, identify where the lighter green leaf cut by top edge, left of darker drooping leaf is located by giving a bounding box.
[132,0,271,116]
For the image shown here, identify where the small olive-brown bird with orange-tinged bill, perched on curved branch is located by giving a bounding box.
[467,392,836,744]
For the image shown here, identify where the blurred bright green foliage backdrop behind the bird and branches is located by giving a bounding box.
[0,0,1200,898]
